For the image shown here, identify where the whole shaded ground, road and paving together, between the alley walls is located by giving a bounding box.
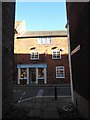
[3,87,82,120]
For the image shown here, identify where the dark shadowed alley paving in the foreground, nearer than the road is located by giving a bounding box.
[2,98,83,120]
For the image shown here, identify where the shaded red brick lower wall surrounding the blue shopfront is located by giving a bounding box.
[14,54,69,83]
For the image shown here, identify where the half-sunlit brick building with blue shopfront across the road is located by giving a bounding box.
[14,21,69,84]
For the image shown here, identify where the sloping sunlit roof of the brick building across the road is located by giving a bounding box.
[18,30,67,38]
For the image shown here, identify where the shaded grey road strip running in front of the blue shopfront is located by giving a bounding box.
[13,86,71,102]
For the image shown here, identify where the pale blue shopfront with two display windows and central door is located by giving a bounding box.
[17,64,47,84]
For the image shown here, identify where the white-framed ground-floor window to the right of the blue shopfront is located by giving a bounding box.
[56,66,65,78]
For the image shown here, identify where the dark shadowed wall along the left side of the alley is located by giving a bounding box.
[2,2,15,115]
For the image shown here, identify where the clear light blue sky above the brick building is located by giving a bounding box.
[15,2,67,31]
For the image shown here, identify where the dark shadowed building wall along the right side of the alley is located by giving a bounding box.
[66,2,90,118]
